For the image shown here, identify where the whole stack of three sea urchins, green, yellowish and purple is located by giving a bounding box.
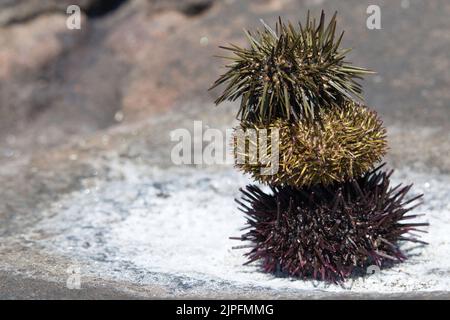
[213,12,427,282]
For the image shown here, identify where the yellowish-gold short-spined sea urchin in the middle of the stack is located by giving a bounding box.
[233,102,387,187]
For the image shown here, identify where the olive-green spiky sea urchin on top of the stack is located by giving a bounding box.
[212,11,371,122]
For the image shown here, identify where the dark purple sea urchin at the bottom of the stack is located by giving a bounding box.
[234,169,428,282]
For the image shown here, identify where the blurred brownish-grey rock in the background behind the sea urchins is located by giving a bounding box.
[0,0,450,164]
